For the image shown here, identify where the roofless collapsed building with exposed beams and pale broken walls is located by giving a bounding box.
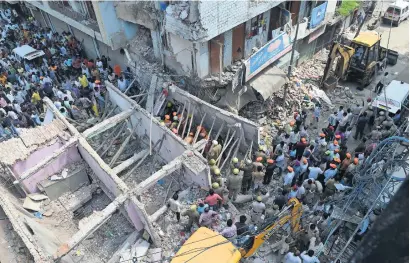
[0,79,259,262]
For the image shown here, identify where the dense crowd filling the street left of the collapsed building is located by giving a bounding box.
[0,5,131,140]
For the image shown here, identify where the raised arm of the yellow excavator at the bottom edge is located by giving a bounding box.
[239,198,303,258]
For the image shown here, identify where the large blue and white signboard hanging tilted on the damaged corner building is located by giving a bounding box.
[246,33,292,81]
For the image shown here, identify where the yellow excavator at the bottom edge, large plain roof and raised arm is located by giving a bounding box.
[171,198,303,263]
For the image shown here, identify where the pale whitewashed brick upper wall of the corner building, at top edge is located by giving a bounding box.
[198,0,283,40]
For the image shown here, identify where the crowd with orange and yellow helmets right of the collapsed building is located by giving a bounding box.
[164,91,397,263]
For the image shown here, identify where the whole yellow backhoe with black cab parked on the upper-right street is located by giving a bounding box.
[321,31,398,88]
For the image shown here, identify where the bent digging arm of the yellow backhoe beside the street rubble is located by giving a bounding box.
[322,42,355,84]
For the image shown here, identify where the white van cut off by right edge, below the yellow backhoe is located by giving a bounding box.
[372,80,409,116]
